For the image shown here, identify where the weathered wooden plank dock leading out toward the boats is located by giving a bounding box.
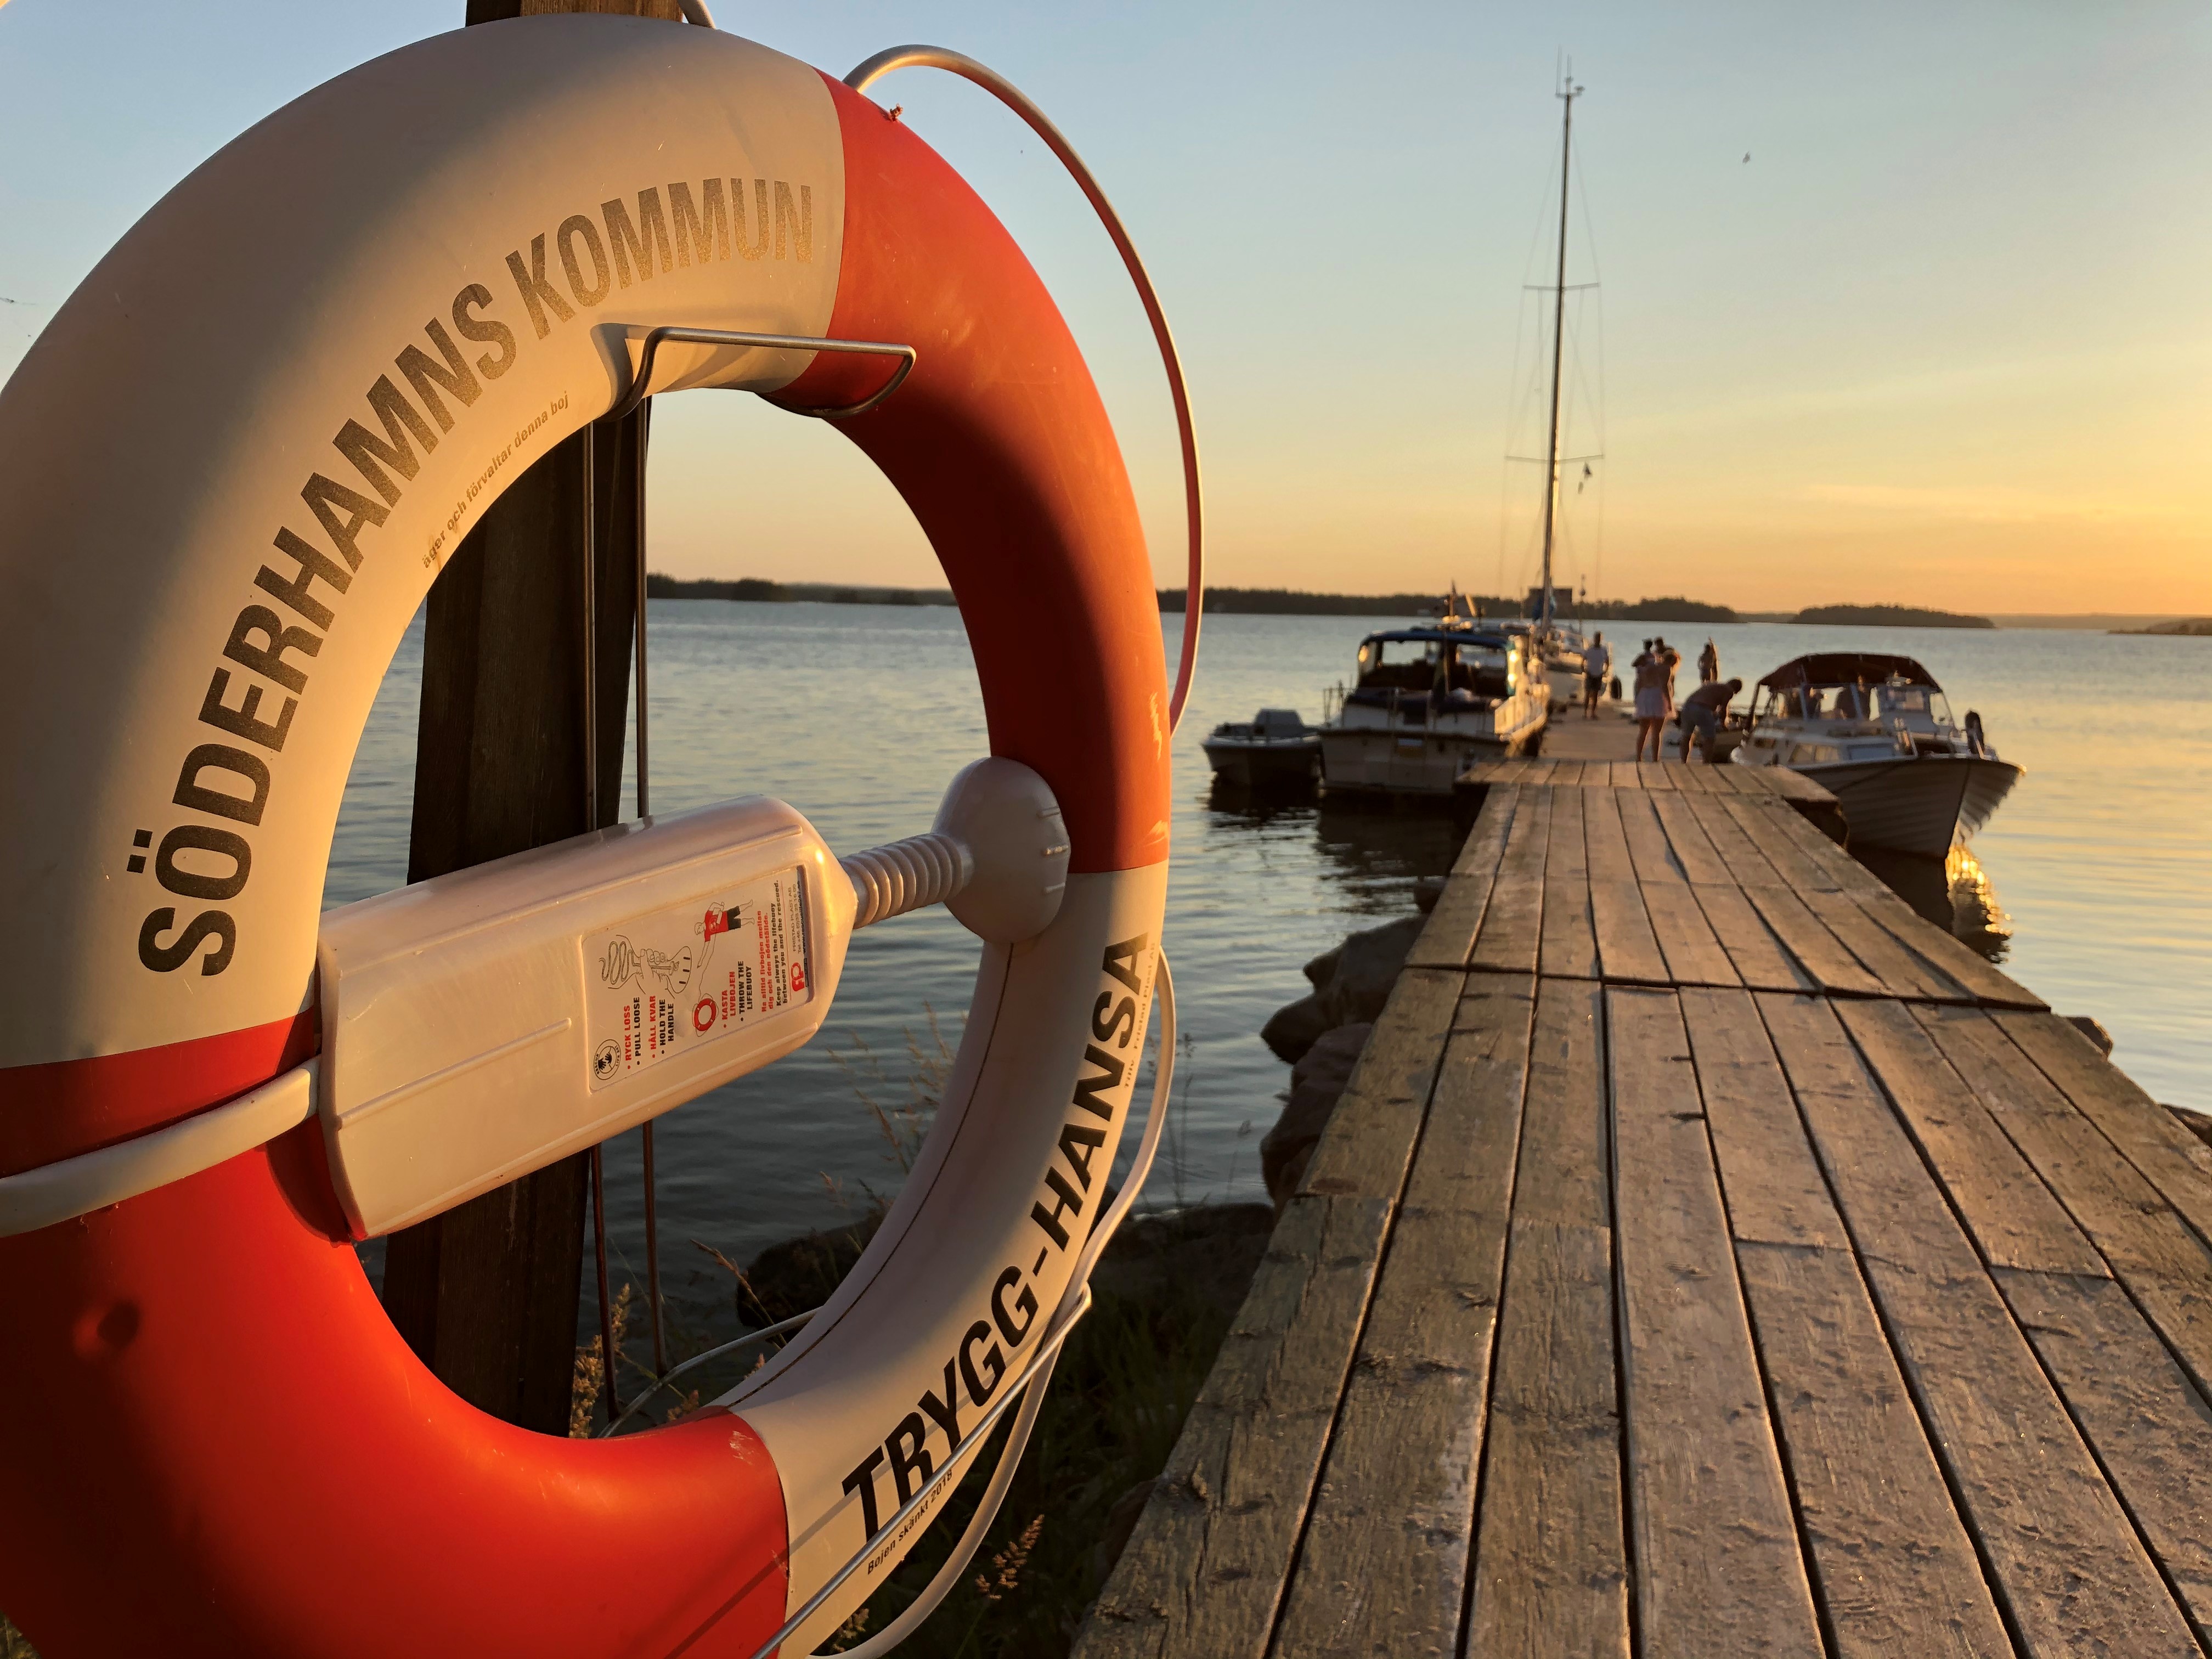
[1075,761,2212,1659]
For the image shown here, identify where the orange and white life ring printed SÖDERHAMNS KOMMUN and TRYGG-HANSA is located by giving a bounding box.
[0,18,1194,1659]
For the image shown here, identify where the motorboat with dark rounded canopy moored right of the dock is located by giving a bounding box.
[1730,650,2019,858]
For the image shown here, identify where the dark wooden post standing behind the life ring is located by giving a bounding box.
[385,0,681,1434]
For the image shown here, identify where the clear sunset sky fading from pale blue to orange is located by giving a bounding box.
[0,0,2212,613]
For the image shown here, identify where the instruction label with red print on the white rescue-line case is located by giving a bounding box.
[584,865,814,1091]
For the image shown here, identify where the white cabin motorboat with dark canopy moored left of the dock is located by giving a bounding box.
[1321,617,1550,797]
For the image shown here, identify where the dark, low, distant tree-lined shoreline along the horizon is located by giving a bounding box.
[646,571,2201,635]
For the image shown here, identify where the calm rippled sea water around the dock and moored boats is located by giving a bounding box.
[328,614,2212,1336]
